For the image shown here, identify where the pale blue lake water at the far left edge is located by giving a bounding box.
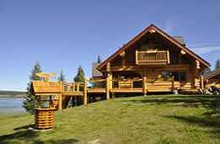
[0,98,25,114]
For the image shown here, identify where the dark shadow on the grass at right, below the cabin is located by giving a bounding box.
[124,95,220,137]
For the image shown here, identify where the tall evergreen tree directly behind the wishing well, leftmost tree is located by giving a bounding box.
[23,62,42,114]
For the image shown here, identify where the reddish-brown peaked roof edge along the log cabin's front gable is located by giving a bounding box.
[97,24,210,70]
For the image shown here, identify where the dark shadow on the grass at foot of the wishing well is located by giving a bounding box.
[0,125,78,144]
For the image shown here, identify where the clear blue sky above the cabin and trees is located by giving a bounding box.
[0,0,220,90]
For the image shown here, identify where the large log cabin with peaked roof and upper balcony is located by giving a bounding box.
[96,24,210,94]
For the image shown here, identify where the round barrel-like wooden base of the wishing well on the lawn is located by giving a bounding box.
[35,108,55,129]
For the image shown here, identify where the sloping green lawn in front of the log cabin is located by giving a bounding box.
[0,95,220,144]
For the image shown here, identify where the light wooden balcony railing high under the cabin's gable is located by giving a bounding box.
[135,51,170,65]
